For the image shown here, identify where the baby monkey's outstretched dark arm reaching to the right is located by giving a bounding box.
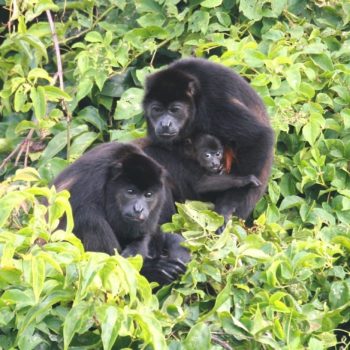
[194,174,261,194]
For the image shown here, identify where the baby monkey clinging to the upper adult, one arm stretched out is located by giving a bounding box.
[184,134,261,194]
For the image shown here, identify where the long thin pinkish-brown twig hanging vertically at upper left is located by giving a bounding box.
[46,10,72,160]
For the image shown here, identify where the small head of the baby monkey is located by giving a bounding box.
[191,134,224,174]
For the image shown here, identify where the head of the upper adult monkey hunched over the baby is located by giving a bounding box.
[143,68,199,143]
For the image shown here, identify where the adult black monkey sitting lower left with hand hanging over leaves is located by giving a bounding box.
[54,143,189,284]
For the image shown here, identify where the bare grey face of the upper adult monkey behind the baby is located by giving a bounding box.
[146,100,194,142]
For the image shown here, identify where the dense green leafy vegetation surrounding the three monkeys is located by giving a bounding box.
[0,0,350,350]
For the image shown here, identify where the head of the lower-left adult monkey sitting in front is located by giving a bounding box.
[109,153,165,231]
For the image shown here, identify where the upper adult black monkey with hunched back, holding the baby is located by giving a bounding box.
[143,58,274,219]
